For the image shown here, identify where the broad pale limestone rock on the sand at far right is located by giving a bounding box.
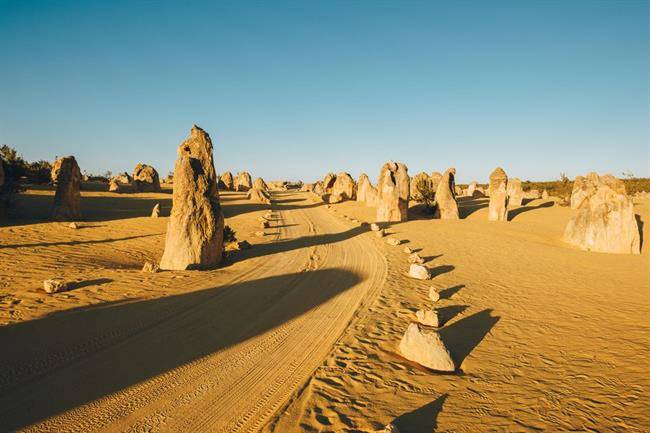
[563,173,641,254]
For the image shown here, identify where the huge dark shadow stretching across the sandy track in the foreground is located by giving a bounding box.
[0,269,360,431]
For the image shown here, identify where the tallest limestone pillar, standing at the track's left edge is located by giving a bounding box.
[160,125,224,270]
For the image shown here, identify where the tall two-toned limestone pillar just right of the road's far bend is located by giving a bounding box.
[377,161,410,222]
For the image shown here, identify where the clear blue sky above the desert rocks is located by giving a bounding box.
[0,0,650,182]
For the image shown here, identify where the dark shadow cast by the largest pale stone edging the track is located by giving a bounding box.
[439,308,500,368]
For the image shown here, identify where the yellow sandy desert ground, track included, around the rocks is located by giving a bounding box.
[0,186,650,433]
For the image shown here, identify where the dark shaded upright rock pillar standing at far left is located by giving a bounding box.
[51,156,81,221]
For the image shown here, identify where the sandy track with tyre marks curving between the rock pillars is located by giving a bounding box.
[0,194,386,432]
